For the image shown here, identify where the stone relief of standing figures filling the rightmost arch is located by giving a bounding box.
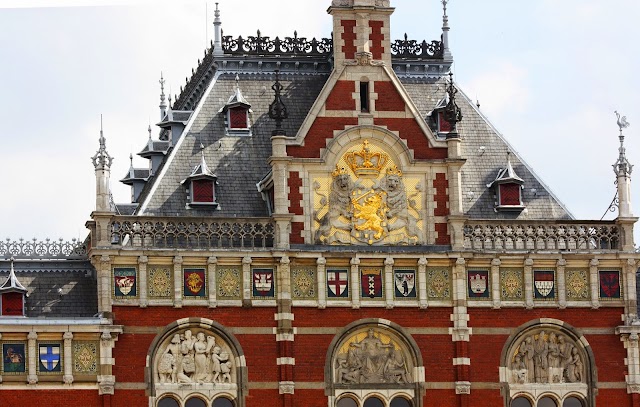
[510,330,585,384]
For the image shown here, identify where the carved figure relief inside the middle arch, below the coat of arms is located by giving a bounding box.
[334,328,412,384]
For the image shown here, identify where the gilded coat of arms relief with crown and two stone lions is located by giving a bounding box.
[313,140,424,245]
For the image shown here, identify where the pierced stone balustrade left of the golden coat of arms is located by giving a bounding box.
[109,216,275,250]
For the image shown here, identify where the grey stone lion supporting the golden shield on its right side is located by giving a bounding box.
[374,166,420,244]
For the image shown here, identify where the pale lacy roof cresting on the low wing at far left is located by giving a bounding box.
[0,239,88,260]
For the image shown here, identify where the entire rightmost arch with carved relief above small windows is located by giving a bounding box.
[502,319,597,407]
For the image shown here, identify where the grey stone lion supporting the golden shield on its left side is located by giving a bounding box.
[315,166,354,244]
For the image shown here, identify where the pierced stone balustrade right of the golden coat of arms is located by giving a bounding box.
[463,220,620,251]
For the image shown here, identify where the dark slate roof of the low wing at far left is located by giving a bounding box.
[0,260,98,318]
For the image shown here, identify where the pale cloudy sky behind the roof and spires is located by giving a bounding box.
[0,0,640,243]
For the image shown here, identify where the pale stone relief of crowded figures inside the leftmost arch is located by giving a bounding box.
[156,329,235,384]
